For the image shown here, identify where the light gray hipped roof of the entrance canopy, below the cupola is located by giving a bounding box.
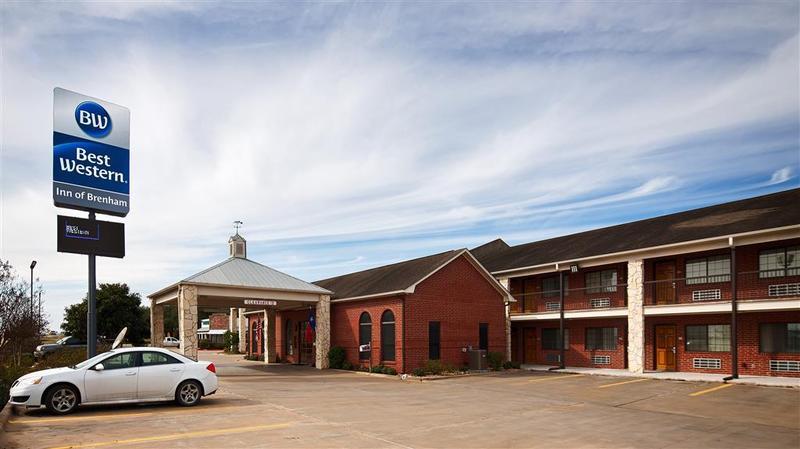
[181,257,330,294]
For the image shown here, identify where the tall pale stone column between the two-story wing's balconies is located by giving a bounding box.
[628,260,644,374]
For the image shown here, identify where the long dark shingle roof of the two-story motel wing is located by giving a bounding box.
[473,189,800,272]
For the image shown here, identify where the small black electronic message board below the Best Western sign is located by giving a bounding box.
[57,215,125,258]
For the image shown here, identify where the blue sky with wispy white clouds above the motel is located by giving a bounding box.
[0,0,800,328]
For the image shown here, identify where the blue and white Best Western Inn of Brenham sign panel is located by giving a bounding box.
[53,87,131,217]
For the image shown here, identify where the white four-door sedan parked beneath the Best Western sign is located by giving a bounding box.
[9,348,217,414]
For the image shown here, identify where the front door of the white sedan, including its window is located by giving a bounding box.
[84,351,139,402]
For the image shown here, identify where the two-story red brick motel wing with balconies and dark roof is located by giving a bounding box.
[472,189,800,377]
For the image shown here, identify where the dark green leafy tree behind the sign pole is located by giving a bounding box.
[61,284,150,344]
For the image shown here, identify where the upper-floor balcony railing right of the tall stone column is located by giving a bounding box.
[644,270,800,305]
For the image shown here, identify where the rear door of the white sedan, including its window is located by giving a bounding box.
[137,351,186,399]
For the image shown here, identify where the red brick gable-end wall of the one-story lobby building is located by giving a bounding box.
[406,256,506,372]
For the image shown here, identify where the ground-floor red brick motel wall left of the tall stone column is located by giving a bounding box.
[511,318,627,369]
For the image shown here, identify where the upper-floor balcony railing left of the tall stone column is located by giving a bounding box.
[511,284,628,313]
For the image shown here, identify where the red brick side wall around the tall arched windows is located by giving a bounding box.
[331,296,403,371]
